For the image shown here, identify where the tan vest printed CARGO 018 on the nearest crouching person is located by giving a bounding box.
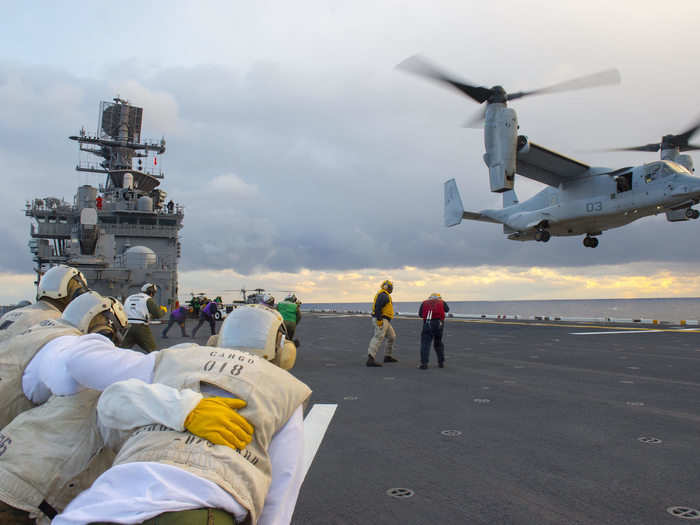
[114,344,311,524]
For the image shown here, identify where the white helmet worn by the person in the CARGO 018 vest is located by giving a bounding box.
[218,304,297,370]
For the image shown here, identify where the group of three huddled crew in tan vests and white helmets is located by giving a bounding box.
[0,265,311,525]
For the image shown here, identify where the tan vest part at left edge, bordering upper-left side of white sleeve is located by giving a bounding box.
[0,319,82,428]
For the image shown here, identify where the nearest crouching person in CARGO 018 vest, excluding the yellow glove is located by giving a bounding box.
[43,305,311,525]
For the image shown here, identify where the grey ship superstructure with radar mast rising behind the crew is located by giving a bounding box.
[25,98,184,310]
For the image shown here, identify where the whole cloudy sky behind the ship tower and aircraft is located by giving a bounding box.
[0,0,700,302]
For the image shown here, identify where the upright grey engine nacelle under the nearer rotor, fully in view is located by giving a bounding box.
[484,103,518,193]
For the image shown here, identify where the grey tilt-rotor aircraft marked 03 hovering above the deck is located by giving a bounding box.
[398,56,700,248]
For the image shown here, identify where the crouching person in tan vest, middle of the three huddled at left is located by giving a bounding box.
[0,292,127,525]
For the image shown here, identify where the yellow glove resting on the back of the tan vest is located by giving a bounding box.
[185,397,254,450]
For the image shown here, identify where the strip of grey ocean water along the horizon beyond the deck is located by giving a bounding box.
[301,297,700,321]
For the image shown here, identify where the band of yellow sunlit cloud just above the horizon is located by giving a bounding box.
[174,263,700,303]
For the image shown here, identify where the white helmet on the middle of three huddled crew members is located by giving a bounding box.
[61,291,129,345]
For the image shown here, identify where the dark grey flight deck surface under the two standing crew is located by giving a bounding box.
[153,314,700,525]
